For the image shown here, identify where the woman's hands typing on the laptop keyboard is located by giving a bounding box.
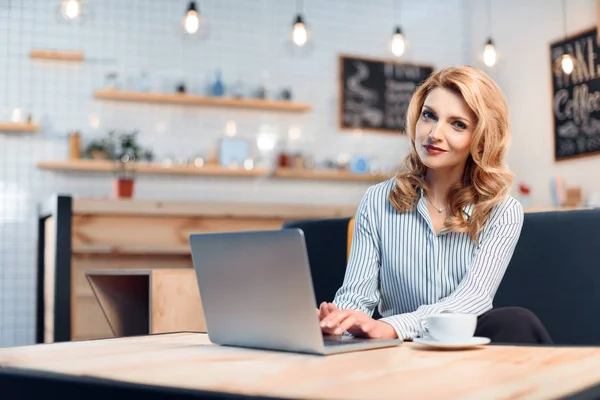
[318,303,398,339]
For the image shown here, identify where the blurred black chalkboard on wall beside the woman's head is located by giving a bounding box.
[339,55,433,134]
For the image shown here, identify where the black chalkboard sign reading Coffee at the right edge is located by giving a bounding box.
[552,29,600,160]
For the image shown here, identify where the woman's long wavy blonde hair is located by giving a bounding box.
[390,66,513,242]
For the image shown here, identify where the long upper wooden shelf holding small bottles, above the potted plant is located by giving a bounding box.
[94,89,312,112]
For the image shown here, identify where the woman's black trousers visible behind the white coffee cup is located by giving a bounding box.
[475,307,553,344]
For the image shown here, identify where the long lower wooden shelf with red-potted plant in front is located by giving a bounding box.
[37,160,269,176]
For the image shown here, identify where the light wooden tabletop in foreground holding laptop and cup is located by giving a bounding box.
[0,333,600,400]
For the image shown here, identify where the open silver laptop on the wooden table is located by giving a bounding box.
[190,229,402,355]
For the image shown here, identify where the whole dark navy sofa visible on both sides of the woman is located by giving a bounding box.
[283,209,600,345]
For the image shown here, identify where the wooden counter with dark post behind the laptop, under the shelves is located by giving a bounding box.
[36,196,355,343]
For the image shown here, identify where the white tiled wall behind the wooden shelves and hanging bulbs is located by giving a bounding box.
[0,0,470,346]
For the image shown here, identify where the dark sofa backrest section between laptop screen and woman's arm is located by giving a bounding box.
[282,217,350,305]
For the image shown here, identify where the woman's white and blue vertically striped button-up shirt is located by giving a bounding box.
[333,178,523,339]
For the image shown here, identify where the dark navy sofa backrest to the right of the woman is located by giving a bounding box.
[494,209,600,344]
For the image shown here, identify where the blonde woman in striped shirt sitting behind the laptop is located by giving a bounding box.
[318,66,551,343]
